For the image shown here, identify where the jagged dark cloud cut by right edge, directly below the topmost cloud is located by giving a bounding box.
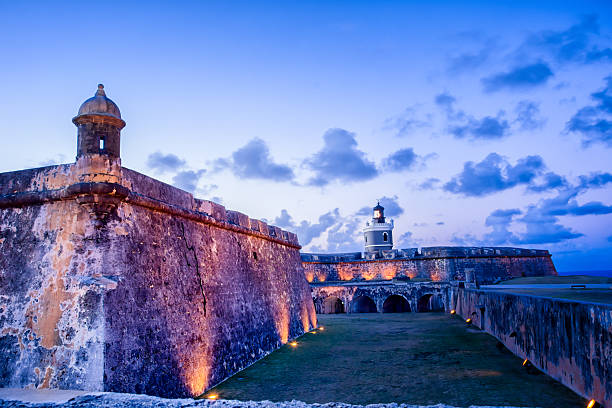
[565,76,612,147]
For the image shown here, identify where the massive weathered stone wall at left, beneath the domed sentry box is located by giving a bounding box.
[0,163,316,396]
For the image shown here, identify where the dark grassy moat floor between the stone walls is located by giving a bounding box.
[206,313,586,408]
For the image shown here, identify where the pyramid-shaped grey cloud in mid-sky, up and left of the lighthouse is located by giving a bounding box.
[304,128,378,186]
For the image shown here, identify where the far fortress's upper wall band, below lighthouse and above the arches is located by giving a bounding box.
[302,247,557,283]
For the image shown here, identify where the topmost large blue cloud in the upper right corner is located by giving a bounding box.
[520,14,612,64]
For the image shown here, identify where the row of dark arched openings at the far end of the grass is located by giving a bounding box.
[321,293,444,314]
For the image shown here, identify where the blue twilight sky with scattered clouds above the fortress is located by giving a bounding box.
[0,0,612,271]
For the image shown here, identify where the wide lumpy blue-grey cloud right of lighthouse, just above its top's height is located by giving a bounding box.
[443,153,546,197]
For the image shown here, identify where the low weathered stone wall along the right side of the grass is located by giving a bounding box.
[454,288,612,408]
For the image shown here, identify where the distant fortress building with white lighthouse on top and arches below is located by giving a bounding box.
[301,203,557,313]
